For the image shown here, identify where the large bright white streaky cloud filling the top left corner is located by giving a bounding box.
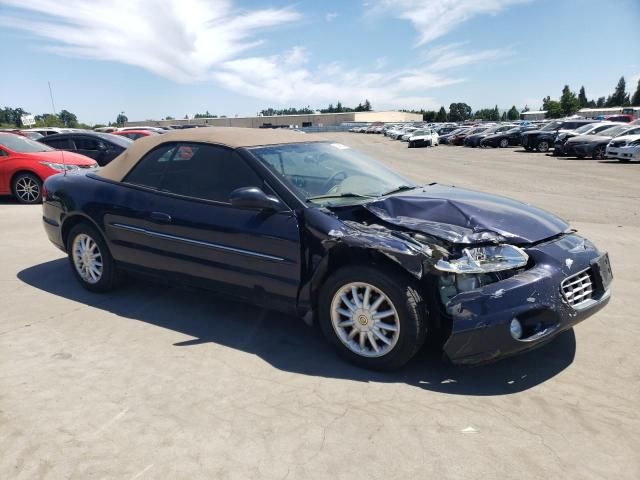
[0,0,300,82]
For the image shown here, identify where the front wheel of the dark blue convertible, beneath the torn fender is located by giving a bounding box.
[319,267,427,370]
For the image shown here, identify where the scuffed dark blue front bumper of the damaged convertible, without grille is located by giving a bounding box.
[444,235,610,364]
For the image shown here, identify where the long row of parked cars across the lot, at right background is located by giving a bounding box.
[351,118,640,161]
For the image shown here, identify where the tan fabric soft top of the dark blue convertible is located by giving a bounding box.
[97,127,326,182]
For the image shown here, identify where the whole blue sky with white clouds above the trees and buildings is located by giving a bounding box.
[0,0,640,123]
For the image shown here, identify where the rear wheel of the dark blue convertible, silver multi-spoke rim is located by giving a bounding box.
[67,223,118,292]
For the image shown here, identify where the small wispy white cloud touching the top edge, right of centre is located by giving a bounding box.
[365,0,533,46]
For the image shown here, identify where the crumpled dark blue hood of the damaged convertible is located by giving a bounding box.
[363,184,569,245]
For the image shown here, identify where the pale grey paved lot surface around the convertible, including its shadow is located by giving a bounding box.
[0,133,640,479]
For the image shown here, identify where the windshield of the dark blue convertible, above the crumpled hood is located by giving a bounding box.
[251,142,416,204]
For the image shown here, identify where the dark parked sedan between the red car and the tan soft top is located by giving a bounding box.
[39,132,133,167]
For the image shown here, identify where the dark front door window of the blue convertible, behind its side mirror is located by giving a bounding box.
[161,144,264,203]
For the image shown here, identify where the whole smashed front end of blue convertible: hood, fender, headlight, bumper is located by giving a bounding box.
[301,187,611,364]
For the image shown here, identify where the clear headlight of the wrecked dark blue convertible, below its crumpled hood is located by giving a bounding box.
[436,245,529,273]
